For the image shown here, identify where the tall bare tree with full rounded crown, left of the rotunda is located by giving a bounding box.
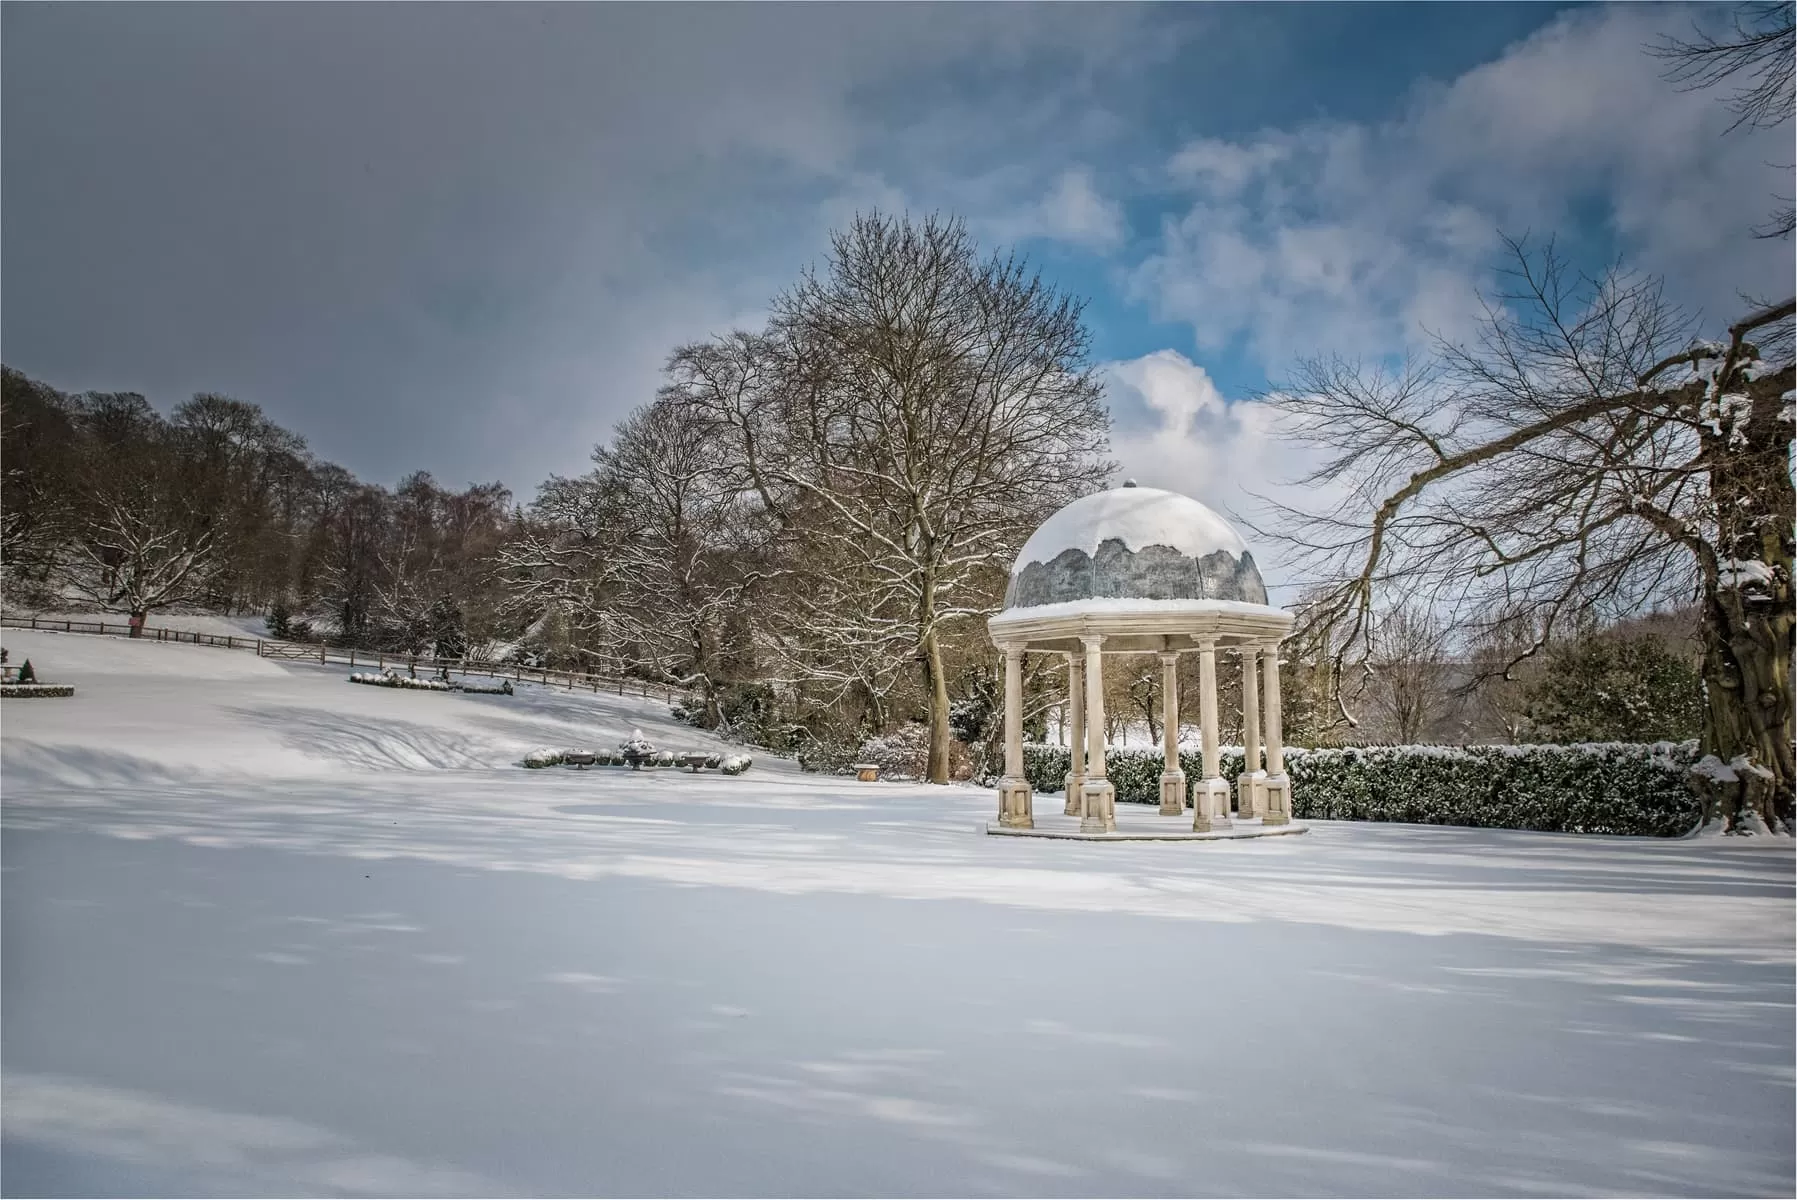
[668,214,1111,783]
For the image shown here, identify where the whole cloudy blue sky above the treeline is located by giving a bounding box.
[0,4,1792,538]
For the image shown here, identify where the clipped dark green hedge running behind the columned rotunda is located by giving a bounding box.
[1024,742,1702,837]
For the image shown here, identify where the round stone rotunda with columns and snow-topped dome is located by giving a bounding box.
[987,481,1305,841]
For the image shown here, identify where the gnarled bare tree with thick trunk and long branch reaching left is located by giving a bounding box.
[1276,243,1793,830]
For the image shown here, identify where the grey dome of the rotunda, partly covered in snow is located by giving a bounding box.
[1005,483,1267,609]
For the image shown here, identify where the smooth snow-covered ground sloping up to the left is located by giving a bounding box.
[0,631,1797,1196]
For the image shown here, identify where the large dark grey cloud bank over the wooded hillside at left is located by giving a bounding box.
[0,4,1157,490]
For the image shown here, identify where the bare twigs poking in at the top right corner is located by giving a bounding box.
[1648,0,1797,237]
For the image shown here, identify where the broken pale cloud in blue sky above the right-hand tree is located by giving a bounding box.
[1130,5,1792,375]
